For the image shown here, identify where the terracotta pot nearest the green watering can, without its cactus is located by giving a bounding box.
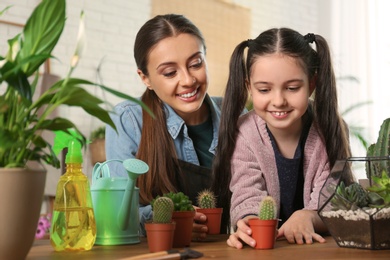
[145,222,176,253]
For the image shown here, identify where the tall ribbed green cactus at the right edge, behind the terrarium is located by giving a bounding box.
[366,118,390,178]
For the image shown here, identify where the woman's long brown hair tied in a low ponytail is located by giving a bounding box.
[134,14,206,205]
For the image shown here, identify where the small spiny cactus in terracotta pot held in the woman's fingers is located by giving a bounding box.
[196,189,223,235]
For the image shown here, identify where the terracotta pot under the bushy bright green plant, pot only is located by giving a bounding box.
[172,211,195,247]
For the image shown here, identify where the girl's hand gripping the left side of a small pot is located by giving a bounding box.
[226,216,256,249]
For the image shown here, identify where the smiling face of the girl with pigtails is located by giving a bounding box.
[249,53,313,137]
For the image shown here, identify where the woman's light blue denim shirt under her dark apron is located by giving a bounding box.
[106,95,222,235]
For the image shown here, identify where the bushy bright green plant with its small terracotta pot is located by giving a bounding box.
[163,192,195,247]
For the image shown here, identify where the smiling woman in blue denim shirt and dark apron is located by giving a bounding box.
[106,14,221,238]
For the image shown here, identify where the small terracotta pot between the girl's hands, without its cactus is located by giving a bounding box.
[249,219,278,249]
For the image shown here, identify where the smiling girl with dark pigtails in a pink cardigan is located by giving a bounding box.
[213,28,350,248]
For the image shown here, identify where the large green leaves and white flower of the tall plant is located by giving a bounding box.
[0,0,151,168]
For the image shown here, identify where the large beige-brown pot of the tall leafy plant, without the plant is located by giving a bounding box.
[0,168,46,260]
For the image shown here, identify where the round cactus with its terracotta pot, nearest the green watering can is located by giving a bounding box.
[145,197,176,253]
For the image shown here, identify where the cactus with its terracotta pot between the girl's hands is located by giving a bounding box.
[248,196,278,249]
